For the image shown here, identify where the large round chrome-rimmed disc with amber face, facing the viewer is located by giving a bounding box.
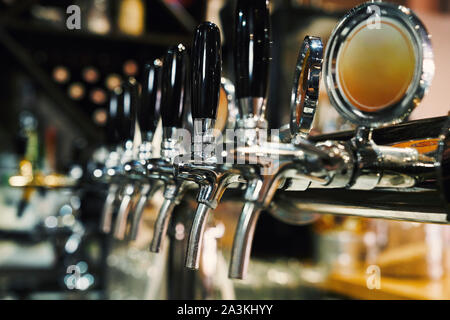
[325,2,434,128]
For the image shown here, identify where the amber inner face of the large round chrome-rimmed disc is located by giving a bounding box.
[336,19,416,112]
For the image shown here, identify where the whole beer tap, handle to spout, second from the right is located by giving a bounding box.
[175,22,242,269]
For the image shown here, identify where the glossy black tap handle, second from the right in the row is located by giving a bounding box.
[191,22,222,119]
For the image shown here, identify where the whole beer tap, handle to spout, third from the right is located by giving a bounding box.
[147,44,189,253]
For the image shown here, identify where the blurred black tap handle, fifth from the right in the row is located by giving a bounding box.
[118,78,139,141]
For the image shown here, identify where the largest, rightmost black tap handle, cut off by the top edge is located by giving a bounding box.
[234,0,271,99]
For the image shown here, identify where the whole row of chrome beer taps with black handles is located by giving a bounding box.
[89,0,444,279]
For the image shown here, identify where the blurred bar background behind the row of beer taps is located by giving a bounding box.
[0,0,450,299]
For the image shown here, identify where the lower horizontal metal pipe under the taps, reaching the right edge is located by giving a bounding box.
[272,189,450,224]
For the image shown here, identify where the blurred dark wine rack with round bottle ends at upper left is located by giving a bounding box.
[0,0,206,148]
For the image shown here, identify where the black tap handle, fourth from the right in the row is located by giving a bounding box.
[141,59,162,137]
